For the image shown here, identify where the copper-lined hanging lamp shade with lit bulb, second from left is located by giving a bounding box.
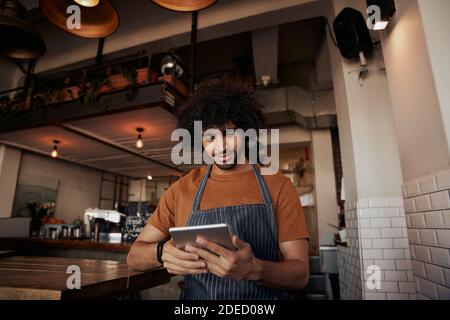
[39,0,119,38]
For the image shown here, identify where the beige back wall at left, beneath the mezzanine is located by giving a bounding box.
[18,152,101,223]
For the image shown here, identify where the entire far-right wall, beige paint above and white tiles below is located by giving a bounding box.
[382,0,450,299]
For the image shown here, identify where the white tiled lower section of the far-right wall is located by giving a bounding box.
[403,170,450,300]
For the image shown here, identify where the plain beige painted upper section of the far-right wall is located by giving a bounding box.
[381,0,450,182]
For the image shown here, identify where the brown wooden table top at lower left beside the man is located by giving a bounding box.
[0,256,170,300]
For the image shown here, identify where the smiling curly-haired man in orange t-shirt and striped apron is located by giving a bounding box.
[127,81,309,299]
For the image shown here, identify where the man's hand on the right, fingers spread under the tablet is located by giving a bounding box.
[186,236,260,281]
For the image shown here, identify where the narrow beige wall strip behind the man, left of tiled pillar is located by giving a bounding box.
[312,130,339,245]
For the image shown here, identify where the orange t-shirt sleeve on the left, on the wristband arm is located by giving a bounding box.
[148,183,178,235]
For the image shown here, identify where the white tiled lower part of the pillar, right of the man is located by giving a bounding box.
[338,198,416,300]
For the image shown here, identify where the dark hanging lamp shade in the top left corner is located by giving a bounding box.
[0,0,47,59]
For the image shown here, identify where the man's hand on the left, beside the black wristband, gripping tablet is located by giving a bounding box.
[161,241,208,275]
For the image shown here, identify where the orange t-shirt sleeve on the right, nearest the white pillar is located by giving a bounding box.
[275,179,309,243]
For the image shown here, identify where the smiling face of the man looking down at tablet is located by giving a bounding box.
[202,122,244,170]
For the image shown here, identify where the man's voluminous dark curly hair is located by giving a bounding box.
[177,79,265,134]
